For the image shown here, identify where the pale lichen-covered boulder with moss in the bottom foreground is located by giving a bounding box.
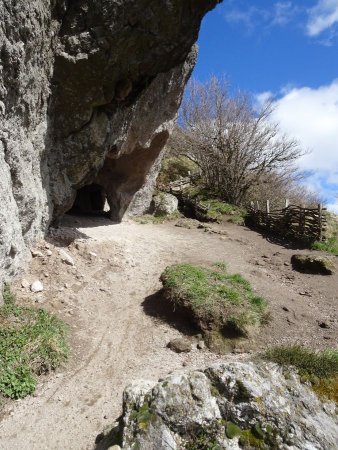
[122,362,338,450]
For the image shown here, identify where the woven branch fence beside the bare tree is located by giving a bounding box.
[249,200,326,241]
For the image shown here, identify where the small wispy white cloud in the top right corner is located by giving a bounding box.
[306,0,338,36]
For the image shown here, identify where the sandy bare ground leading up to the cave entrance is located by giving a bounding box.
[0,216,338,450]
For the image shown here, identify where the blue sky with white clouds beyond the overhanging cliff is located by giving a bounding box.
[194,0,338,212]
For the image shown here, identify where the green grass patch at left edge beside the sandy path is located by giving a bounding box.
[0,287,69,399]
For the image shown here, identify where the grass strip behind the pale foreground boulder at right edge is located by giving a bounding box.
[263,346,338,403]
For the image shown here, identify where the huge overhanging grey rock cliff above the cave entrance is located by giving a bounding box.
[0,0,219,292]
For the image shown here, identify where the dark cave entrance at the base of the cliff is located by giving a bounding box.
[68,183,109,215]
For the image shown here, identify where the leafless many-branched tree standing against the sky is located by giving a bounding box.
[177,77,304,205]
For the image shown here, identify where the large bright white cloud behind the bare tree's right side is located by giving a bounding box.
[256,79,338,209]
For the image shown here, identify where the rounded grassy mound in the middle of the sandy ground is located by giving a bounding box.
[161,263,267,337]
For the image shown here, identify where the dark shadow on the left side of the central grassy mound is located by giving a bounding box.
[142,289,200,336]
